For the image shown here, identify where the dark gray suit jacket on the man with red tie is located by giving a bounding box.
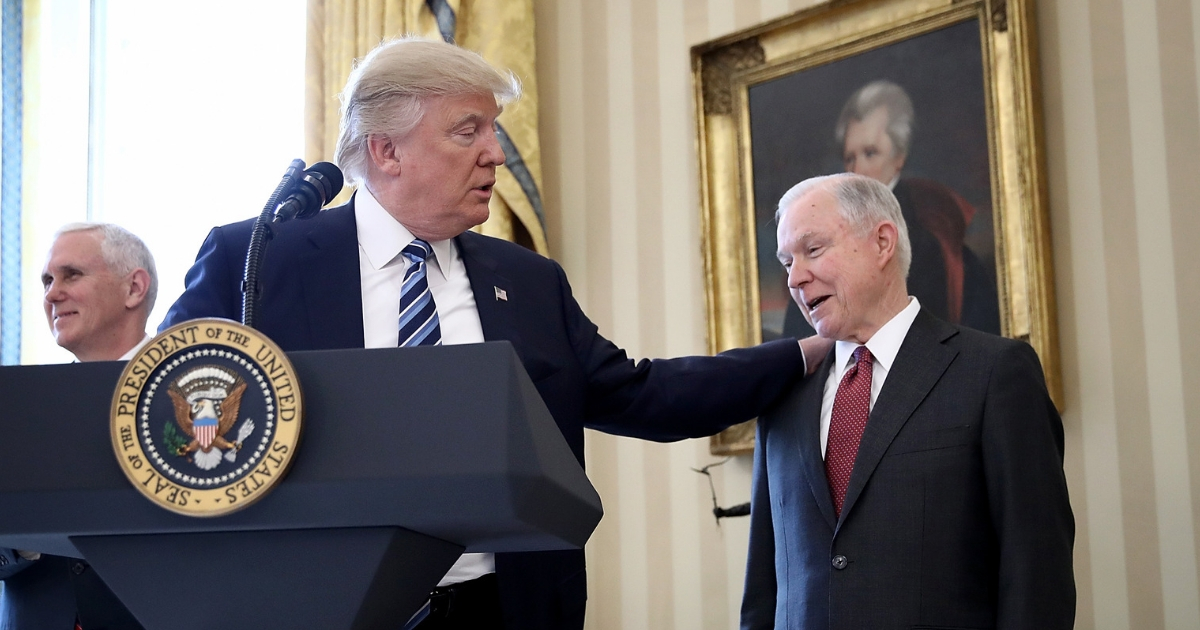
[742,310,1075,630]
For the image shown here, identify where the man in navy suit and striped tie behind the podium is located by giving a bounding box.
[163,40,823,630]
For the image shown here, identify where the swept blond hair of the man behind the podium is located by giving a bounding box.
[334,36,521,184]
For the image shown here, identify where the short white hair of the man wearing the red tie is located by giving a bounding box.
[775,173,912,277]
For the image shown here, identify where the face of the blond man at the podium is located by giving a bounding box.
[372,94,504,240]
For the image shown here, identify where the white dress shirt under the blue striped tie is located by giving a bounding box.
[354,187,496,586]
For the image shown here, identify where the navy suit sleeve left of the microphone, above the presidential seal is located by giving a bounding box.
[158,223,245,331]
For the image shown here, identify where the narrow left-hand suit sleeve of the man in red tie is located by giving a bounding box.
[742,420,778,630]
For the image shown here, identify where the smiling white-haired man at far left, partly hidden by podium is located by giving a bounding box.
[0,223,158,630]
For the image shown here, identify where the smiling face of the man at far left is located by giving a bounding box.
[42,232,143,359]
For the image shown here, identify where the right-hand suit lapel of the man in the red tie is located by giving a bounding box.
[841,308,958,521]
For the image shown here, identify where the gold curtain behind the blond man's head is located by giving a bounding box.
[305,0,548,254]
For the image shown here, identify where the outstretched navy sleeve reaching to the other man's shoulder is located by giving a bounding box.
[554,264,804,442]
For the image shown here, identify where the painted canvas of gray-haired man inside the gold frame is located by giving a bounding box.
[750,20,1001,340]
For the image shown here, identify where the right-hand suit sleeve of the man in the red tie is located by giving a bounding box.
[983,343,1075,630]
